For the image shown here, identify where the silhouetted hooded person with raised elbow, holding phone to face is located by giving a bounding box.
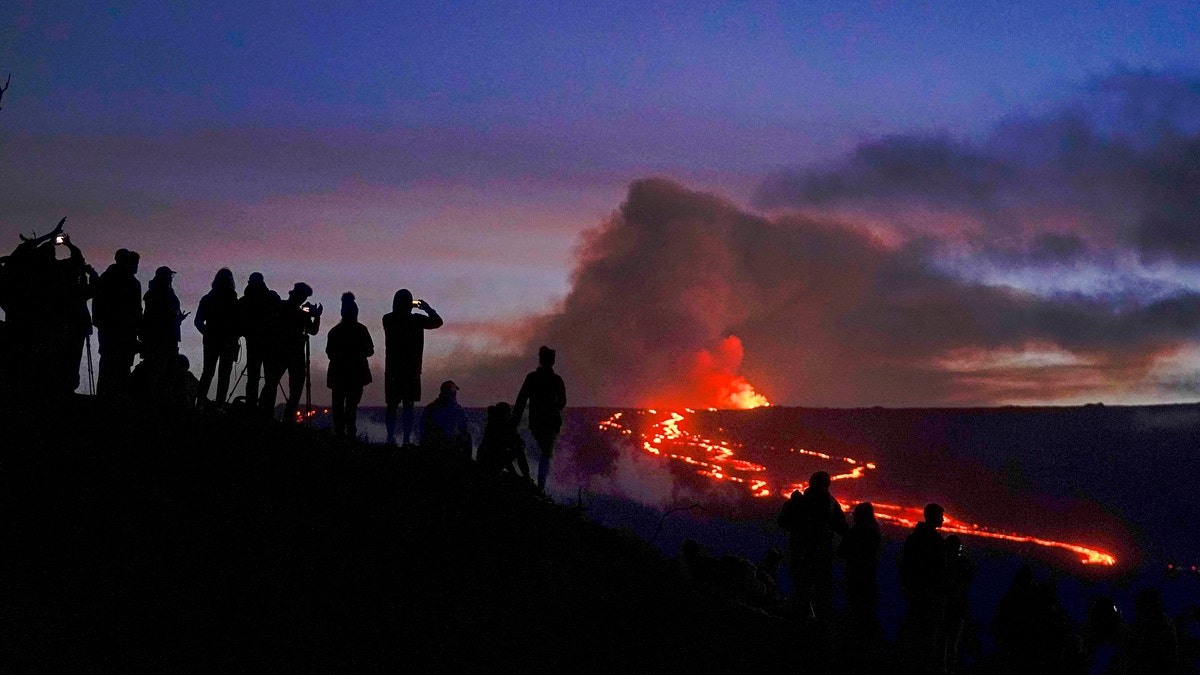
[383,288,444,446]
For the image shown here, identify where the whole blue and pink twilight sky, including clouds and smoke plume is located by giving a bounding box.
[0,1,1200,407]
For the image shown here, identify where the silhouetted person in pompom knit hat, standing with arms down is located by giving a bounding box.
[325,293,374,438]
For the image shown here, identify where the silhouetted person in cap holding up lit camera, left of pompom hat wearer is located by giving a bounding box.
[258,281,324,422]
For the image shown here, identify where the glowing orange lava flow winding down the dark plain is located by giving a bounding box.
[600,408,1116,566]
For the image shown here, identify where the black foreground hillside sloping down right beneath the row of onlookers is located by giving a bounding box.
[0,398,814,673]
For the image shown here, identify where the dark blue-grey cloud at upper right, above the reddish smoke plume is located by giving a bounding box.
[758,72,1200,264]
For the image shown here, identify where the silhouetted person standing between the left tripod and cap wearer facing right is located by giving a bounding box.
[91,249,142,396]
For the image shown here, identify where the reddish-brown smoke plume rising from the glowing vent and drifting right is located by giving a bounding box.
[456,179,1200,406]
